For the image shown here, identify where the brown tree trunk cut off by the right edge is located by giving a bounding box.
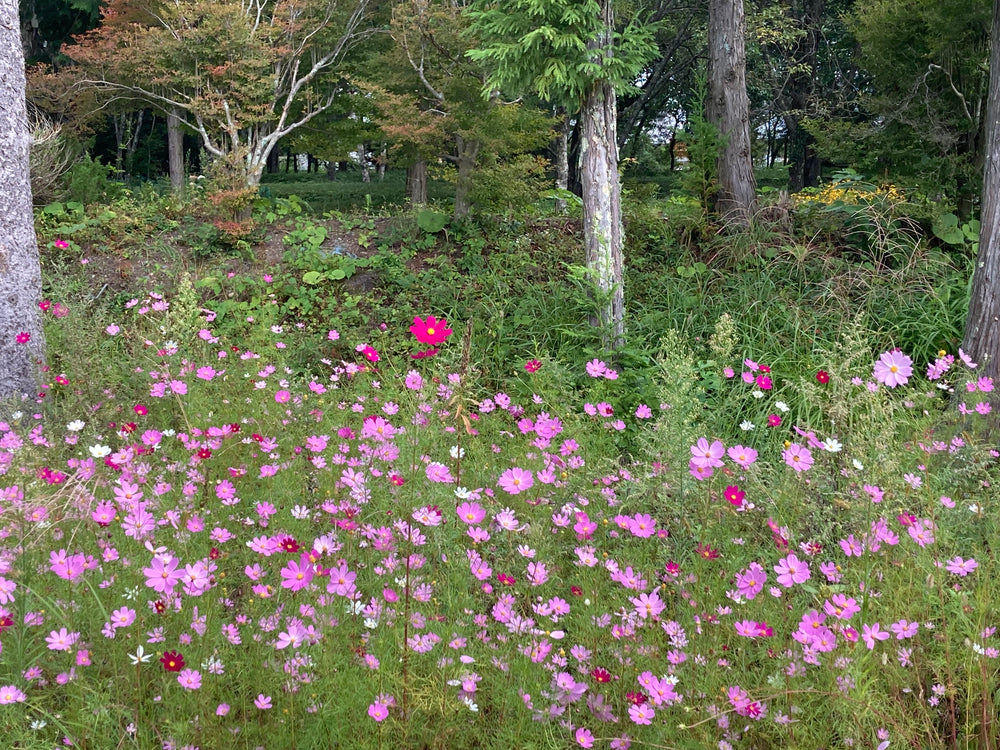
[962,0,1000,379]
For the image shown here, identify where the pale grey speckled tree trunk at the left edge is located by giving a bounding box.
[0,0,45,400]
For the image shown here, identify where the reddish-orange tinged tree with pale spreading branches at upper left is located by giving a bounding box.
[66,0,374,187]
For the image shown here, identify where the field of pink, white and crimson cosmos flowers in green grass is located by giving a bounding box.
[0,188,1000,750]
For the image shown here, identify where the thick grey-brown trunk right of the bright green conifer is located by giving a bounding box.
[706,0,757,226]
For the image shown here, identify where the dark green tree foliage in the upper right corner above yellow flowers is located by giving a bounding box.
[836,0,990,213]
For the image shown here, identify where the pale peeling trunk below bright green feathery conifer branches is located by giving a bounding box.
[578,0,625,350]
